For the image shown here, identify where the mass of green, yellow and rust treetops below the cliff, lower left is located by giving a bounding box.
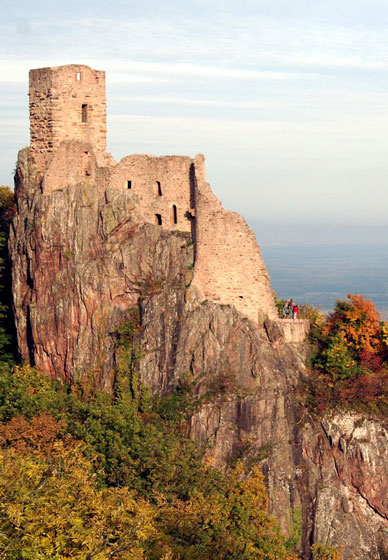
[0,363,300,560]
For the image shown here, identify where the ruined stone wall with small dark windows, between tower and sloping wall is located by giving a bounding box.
[111,155,199,232]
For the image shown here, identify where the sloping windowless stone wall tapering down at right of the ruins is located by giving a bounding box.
[193,154,277,321]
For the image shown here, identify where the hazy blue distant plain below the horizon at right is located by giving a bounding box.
[261,245,388,319]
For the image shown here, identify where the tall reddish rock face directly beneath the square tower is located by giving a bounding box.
[10,150,193,388]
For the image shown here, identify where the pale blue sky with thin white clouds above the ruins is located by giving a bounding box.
[0,0,388,245]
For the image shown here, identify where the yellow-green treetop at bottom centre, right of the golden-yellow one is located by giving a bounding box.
[155,463,286,560]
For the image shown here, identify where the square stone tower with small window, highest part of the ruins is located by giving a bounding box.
[29,64,106,168]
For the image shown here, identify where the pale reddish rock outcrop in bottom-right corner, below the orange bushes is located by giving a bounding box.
[301,413,388,560]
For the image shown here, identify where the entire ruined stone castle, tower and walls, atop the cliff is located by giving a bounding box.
[29,65,304,330]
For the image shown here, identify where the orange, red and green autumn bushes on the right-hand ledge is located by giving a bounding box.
[306,294,388,416]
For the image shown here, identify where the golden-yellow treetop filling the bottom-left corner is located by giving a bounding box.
[0,441,155,560]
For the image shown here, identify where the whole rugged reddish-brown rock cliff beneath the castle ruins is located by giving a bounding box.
[10,150,388,560]
